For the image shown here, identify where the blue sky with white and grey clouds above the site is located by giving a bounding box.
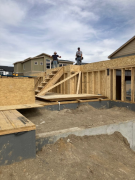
[0,0,135,66]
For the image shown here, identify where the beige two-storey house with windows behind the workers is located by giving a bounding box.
[14,53,74,76]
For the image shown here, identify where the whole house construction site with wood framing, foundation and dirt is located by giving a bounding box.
[0,35,135,180]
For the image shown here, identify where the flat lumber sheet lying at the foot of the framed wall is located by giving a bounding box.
[38,94,106,101]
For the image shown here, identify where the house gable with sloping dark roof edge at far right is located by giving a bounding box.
[108,36,135,59]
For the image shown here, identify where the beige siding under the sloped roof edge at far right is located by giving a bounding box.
[111,39,135,58]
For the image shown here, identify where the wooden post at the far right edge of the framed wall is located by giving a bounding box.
[131,67,135,102]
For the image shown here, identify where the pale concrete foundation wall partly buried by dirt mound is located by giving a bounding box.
[36,120,135,151]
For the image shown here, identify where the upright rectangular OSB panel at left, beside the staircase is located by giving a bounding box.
[0,78,35,106]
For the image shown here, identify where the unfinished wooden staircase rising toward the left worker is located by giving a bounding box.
[35,67,63,97]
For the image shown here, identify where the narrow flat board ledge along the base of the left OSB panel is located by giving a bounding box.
[0,103,43,111]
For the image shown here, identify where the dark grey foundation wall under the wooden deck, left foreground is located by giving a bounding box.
[0,130,36,165]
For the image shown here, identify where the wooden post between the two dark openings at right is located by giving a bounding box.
[121,68,125,101]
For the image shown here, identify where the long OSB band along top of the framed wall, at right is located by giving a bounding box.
[80,56,135,72]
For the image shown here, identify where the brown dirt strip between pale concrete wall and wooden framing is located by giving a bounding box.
[20,104,135,134]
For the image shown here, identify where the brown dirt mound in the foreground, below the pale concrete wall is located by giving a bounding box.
[0,132,135,180]
